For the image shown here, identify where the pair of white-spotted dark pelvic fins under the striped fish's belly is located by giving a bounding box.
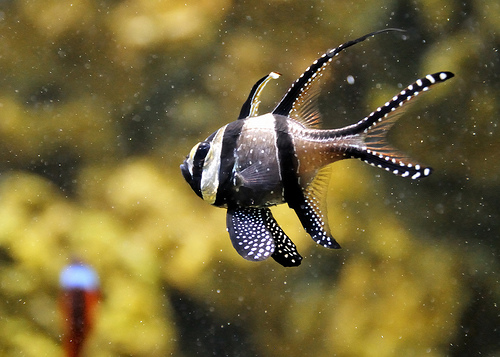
[227,208,302,266]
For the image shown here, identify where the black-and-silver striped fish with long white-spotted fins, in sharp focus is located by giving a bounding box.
[180,28,454,267]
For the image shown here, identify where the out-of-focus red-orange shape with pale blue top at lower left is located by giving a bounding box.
[59,262,100,357]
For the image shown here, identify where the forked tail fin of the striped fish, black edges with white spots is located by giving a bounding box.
[342,72,454,179]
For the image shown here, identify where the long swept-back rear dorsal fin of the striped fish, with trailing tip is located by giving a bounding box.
[272,28,403,127]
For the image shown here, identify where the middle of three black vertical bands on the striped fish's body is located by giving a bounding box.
[214,120,246,206]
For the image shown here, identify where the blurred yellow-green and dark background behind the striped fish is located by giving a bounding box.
[0,0,500,357]
